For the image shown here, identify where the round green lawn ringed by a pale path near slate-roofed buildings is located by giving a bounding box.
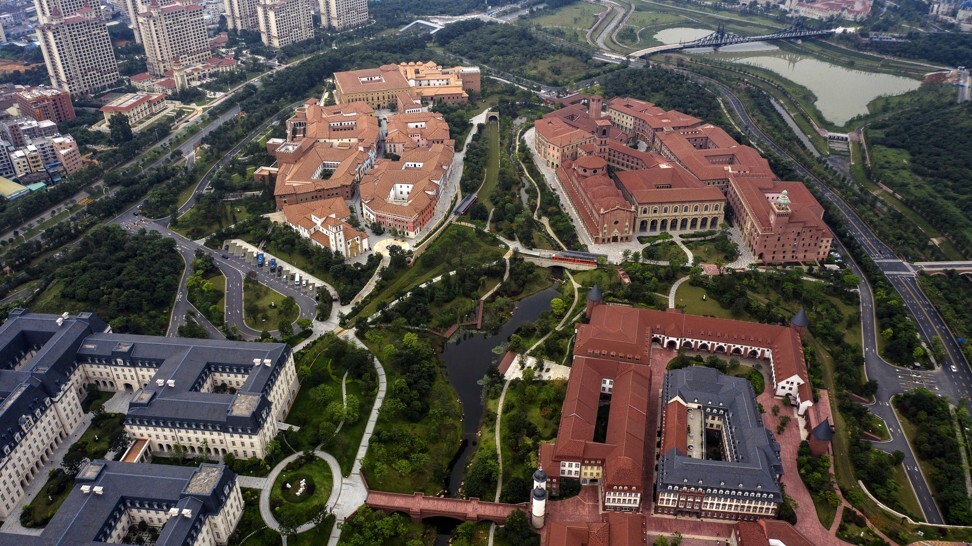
[270,456,334,526]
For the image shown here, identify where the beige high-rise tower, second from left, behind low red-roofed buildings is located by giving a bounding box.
[136,0,210,76]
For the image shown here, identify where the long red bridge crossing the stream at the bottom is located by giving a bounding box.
[365,491,526,523]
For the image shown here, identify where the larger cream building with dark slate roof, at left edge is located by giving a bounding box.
[0,310,297,518]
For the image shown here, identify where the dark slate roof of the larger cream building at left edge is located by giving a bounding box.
[0,309,290,453]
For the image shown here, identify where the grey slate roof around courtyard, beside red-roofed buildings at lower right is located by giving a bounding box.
[656,366,783,502]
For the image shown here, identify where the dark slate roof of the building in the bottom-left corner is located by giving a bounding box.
[0,461,236,546]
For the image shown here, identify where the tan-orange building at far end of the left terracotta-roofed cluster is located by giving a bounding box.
[334,61,480,110]
